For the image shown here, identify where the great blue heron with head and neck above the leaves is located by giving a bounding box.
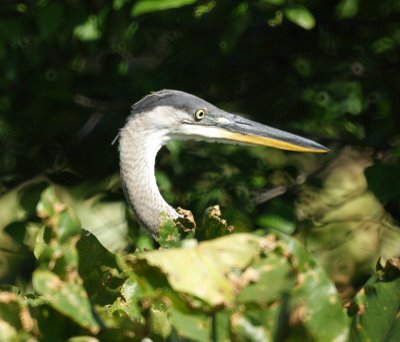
[119,90,328,236]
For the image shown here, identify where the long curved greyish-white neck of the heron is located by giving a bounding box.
[119,117,178,234]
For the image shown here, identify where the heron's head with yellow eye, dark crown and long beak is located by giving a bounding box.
[132,90,328,153]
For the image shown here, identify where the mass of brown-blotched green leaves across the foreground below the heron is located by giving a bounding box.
[0,186,400,341]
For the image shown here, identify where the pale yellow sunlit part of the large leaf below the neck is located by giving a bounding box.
[139,234,261,305]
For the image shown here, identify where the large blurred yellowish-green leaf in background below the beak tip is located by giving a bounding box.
[296,149,400,299]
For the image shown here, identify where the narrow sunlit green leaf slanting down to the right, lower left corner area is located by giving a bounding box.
[32,270,100,333]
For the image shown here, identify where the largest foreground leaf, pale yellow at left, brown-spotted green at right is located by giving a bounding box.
[131,234,349,342]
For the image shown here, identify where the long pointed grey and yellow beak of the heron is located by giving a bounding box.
[212,113,329,153]
